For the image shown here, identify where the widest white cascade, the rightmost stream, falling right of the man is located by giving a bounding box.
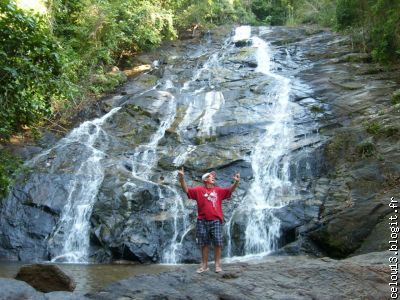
[227,29,294,255]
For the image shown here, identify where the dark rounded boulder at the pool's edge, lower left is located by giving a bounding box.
[15,264,76,293]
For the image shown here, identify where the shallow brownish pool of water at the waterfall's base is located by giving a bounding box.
[0,261,179,293]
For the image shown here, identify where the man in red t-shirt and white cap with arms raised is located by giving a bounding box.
[178,168,240,273]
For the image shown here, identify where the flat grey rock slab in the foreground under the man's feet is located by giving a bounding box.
[86,252,390,300]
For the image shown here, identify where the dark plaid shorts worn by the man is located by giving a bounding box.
[196,220,222,246]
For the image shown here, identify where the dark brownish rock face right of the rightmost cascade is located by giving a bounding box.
[269,28,400,258]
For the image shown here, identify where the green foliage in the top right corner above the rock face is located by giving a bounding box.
[289,0,400,63]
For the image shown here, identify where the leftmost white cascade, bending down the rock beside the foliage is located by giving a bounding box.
[47,108,119,262]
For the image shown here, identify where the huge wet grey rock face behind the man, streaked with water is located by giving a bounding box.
[0,27,400,263]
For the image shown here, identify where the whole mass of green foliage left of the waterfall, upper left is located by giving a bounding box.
[0,0,180,139]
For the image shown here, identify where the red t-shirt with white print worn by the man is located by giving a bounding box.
[187,185,232,221]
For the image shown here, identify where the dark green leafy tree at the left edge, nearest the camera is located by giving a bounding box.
[0,0,63,139]
